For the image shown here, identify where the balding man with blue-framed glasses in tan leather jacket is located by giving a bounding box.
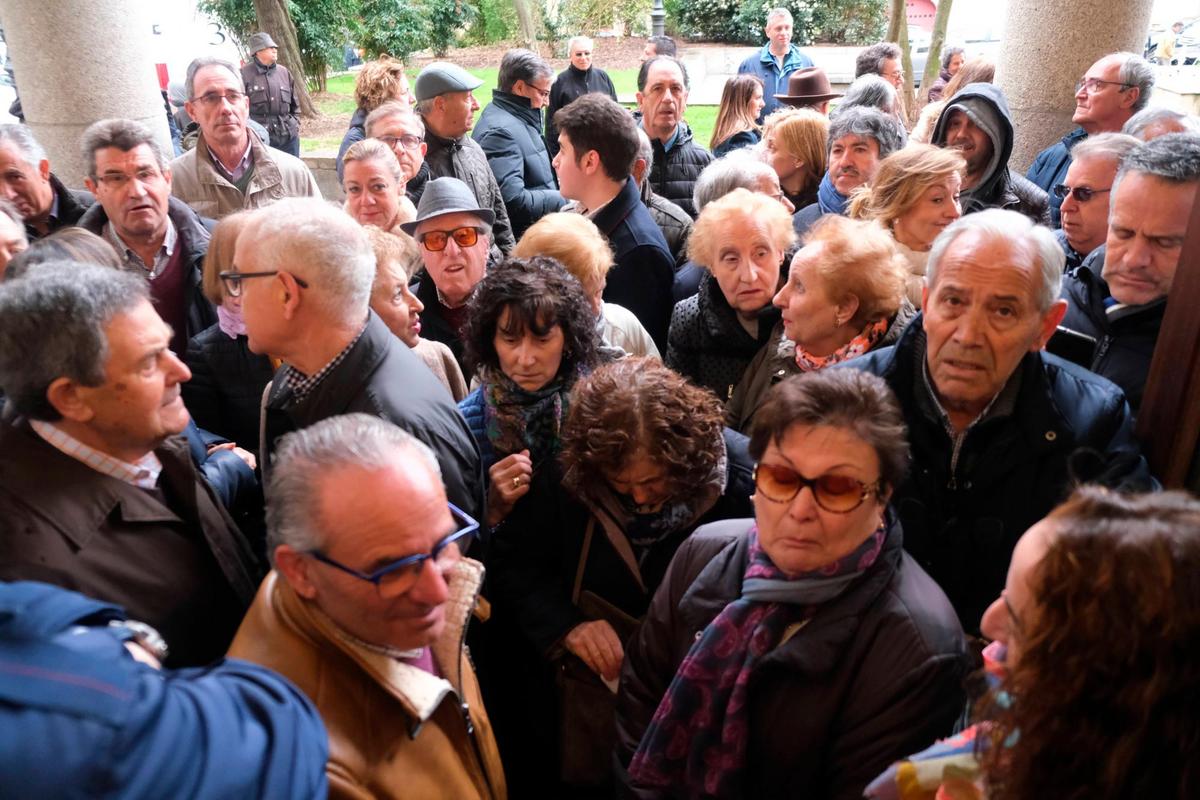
[229,414,506,800]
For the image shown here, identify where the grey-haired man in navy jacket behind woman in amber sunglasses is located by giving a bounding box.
[846,210,1157,633]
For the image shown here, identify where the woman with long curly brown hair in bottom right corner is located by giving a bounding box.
[868,487,1200,800]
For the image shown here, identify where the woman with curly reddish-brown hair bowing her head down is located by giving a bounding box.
[490,359,752,796]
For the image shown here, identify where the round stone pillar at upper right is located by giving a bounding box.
[997,0,1153,174]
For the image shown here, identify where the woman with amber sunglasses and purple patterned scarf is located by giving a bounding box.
[617,369,968,799]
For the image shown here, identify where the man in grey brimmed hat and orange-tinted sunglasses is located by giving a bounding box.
[400,178,496,374]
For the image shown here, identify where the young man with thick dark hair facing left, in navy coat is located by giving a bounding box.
[554,94,674,351]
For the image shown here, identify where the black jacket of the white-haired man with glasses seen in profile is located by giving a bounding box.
[259,312,484,519]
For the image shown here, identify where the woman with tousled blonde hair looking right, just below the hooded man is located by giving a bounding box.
[850,144,966,308]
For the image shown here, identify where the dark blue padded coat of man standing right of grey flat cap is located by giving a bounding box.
[470,89,566,239]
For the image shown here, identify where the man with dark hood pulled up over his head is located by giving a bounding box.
[931,83,1050,225]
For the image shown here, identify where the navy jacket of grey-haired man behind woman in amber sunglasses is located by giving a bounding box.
[841,315,1158,633]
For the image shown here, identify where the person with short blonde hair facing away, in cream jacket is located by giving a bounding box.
[512,212,660,359]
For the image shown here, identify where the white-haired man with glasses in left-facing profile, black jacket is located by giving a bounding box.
[229,198,484,515]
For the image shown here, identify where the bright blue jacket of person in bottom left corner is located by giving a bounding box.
[0,582,329,799]
